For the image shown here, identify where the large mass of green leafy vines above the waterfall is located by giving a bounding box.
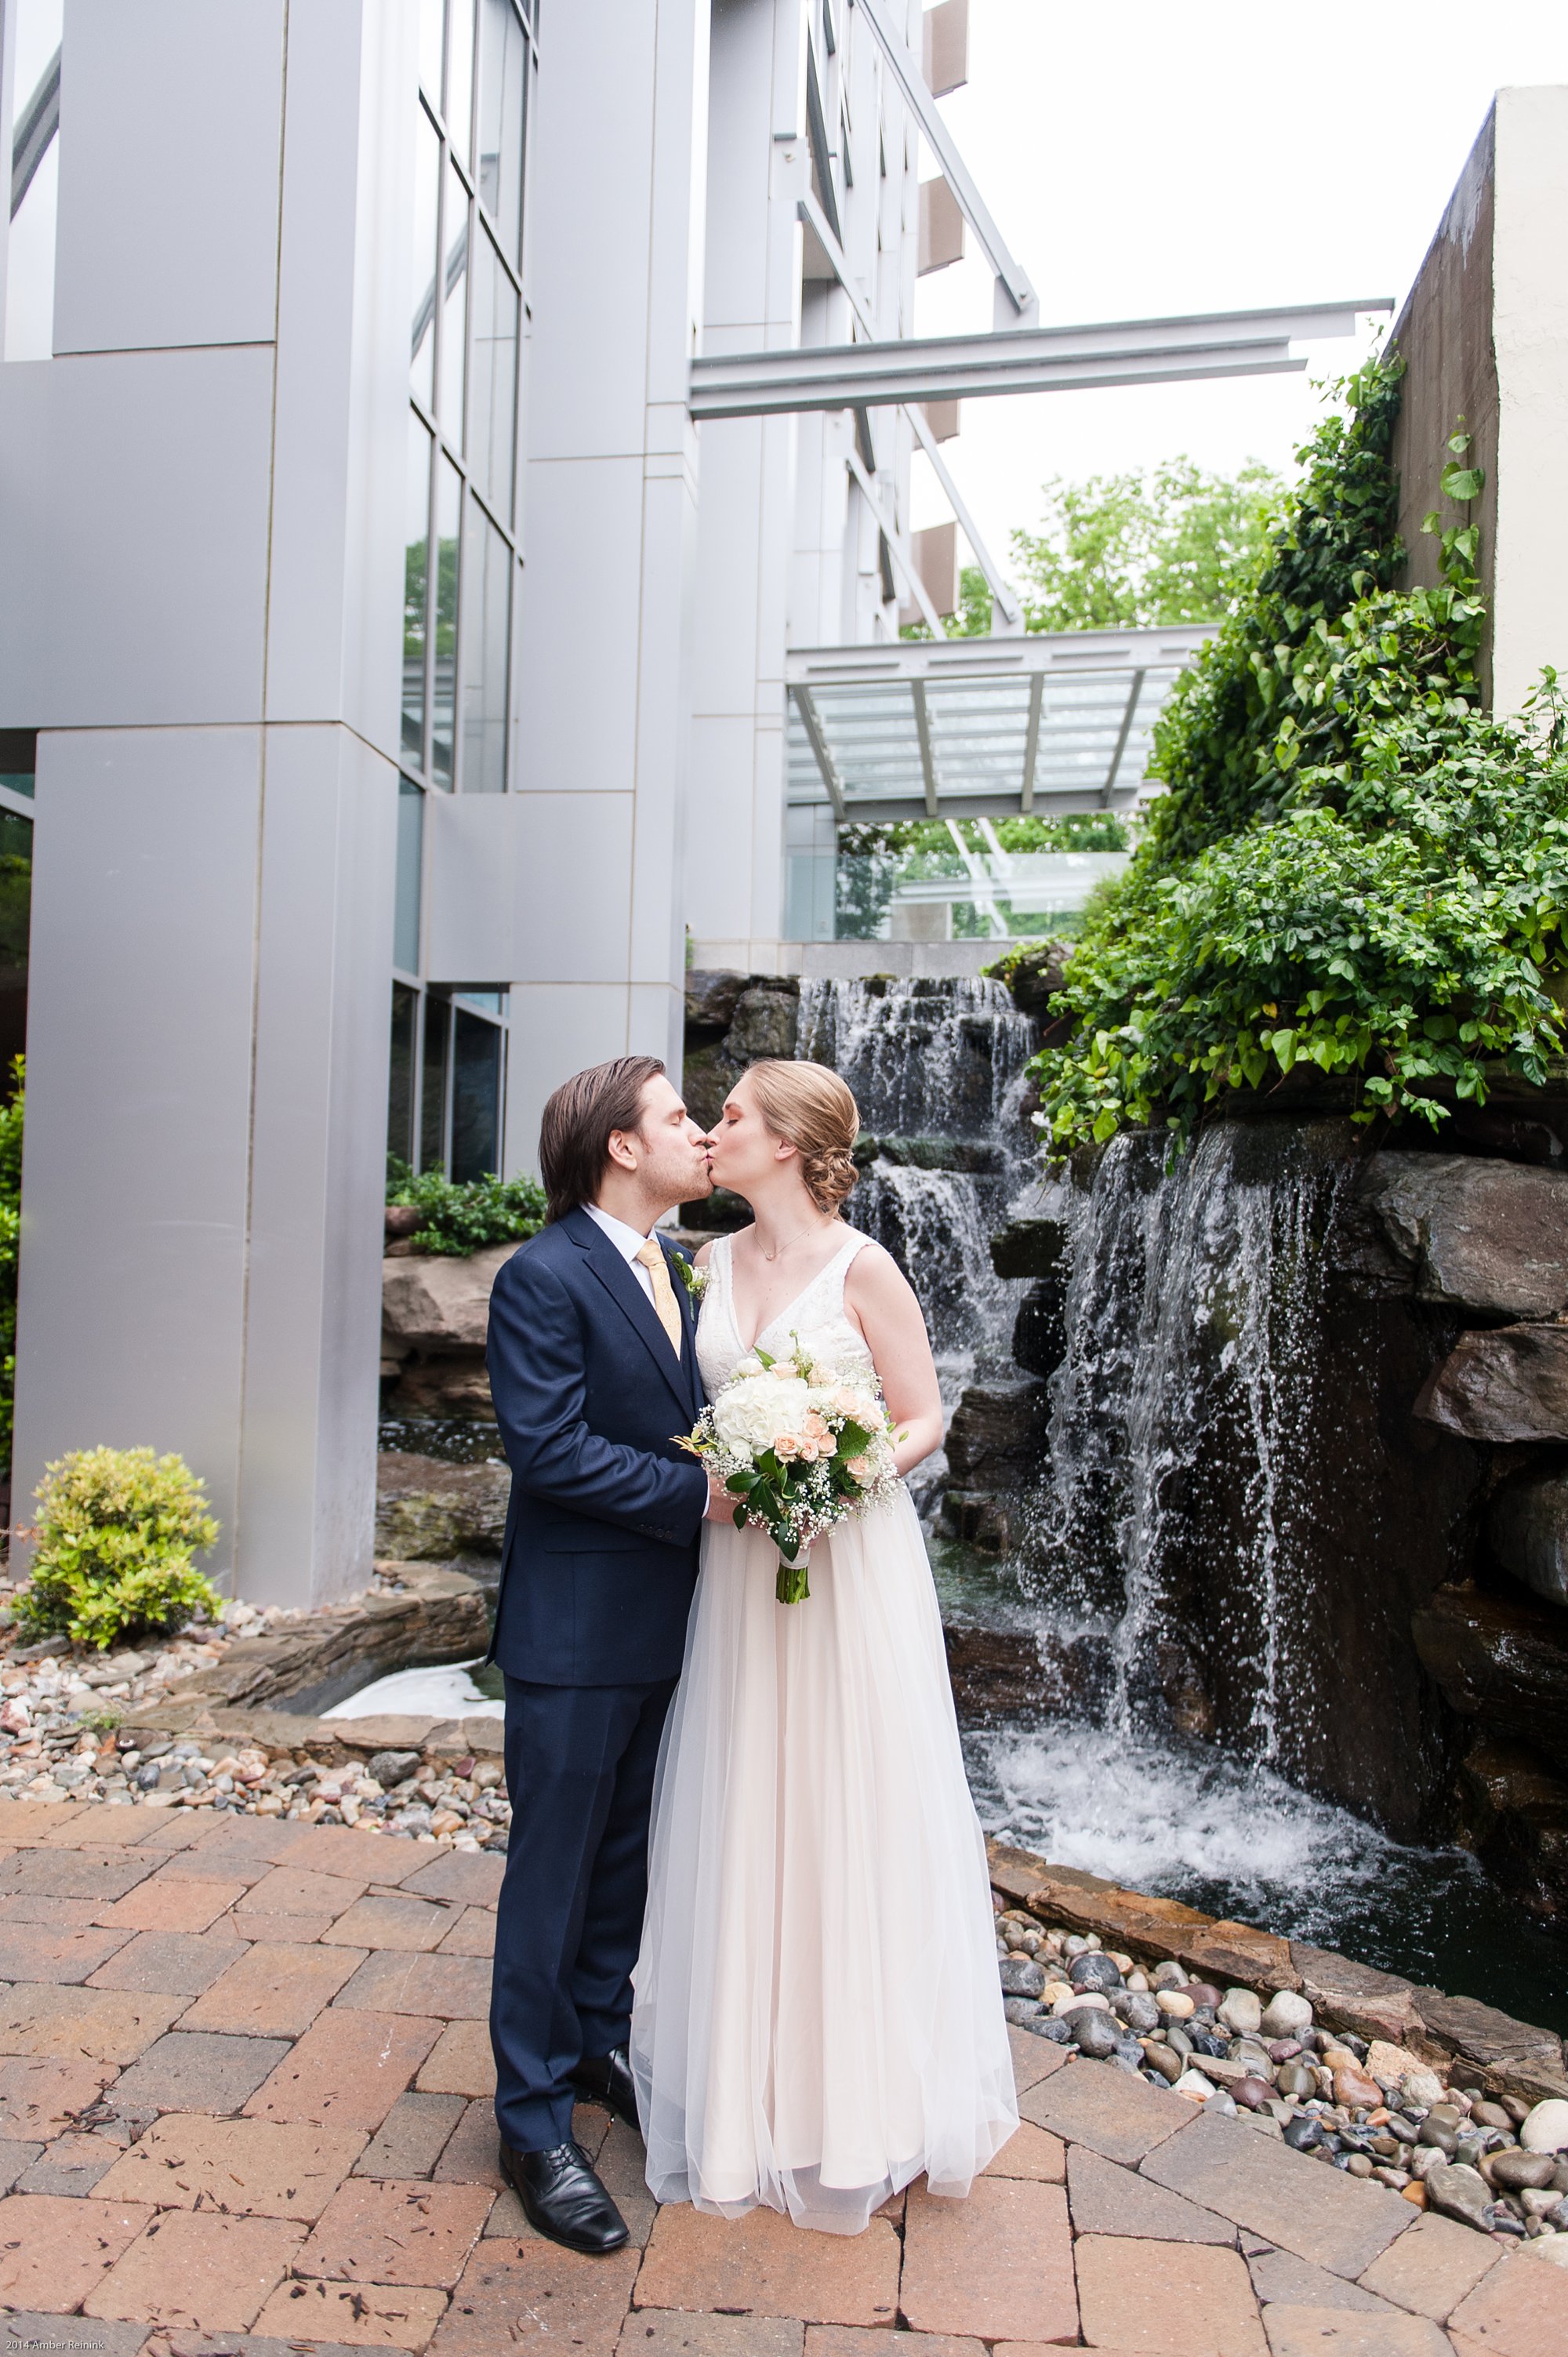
[1033,363,1568,1153]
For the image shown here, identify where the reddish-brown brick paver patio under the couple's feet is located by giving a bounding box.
[0,1803,1568,2357]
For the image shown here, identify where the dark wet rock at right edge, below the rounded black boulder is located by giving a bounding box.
[1413,1586,1568,1770]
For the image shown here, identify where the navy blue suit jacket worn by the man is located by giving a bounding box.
[486,1211,707,1685]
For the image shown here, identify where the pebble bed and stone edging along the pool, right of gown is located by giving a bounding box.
[990,1843,1568,2256]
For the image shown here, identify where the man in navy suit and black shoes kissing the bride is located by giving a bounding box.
[488,1056,712,2253]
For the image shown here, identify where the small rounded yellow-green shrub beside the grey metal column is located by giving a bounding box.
[16,1450,222,1650]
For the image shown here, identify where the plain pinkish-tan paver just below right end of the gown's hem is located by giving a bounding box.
[901,2178,1077,2341]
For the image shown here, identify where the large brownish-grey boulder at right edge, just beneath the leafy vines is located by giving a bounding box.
[1356,1153,1568,1317]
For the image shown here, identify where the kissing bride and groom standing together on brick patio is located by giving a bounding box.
[488,1056,1018,2253]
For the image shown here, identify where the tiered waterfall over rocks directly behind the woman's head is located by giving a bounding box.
[797,975,1035,1396]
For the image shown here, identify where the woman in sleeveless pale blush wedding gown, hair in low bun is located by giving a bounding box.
[632,1063,1018,2235]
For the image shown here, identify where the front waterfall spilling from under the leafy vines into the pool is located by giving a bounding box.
[1023,1122,1346,1773]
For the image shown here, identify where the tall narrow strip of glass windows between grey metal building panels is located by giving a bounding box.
[387,0,538,1178]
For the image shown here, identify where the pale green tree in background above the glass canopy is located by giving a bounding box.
[1011,457,1285,630]
